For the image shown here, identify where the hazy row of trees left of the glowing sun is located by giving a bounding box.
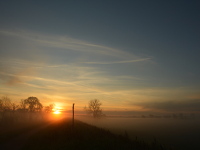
[0,96,54,125]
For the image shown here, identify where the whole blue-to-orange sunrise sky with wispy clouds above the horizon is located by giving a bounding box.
[0,0,200,113]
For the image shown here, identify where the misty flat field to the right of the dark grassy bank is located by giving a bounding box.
[77,117,200,150]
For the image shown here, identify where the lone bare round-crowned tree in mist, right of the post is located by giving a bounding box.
[84,99,104,118]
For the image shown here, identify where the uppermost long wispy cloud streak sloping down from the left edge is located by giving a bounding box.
[0,30,138,59]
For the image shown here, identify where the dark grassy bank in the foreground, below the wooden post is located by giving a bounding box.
[1,120,173,150]
